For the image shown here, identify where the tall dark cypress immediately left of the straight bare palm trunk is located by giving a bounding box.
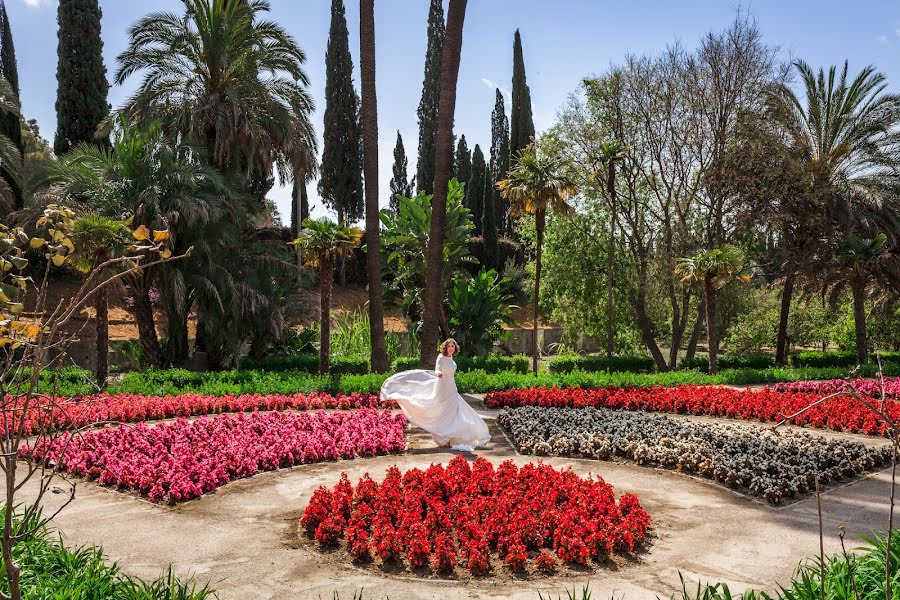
[319,0,363,226]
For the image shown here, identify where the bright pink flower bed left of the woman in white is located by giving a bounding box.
[22,409,406,504]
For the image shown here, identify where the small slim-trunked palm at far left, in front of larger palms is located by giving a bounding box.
[71,212,129,388]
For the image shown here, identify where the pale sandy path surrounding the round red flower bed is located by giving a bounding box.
[17,397,890,600]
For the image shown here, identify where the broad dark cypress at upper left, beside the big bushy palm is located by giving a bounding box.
[53,0,109,156]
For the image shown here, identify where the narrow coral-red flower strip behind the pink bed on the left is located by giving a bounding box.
[7,392,396,433]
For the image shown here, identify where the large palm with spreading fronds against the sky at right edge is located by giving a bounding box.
[768,61,900,368]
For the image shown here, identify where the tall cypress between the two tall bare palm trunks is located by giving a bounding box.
[416,0,444,194]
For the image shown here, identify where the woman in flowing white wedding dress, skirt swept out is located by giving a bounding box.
[381,338,491,452]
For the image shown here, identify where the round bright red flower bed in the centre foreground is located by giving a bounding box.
[300,456,650,575]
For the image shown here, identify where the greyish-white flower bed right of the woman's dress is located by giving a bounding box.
[498,406,891,504]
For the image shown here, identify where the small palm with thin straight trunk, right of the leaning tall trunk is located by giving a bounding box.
[497,142,577,374]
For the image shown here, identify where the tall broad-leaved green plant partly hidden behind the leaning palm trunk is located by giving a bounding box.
[381,179,472,326]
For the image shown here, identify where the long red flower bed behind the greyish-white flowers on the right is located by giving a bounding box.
[484,385,900,435]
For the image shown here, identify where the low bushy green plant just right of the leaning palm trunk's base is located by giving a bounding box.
[449,268,516,356]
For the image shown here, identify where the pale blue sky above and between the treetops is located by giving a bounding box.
[6,0,900,223]
